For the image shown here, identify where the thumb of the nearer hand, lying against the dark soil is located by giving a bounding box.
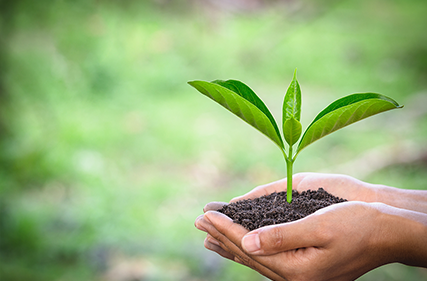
[242,217,325,255]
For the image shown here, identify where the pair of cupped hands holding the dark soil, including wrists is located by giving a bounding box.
[195,173,427,280]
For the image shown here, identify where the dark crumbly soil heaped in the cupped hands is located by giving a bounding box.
[218,188,347,230]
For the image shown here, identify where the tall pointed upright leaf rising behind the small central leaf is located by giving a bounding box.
[282,69,301,121]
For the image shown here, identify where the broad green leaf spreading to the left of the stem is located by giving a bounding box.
[188,80,283,149]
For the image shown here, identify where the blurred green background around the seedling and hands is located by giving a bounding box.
[0,0,427,281]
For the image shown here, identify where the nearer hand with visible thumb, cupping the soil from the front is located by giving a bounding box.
[196,202,427,280]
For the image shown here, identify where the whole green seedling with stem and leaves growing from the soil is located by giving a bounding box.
[188,69,403,203]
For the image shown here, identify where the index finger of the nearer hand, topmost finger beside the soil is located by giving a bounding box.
[205,212,285,281]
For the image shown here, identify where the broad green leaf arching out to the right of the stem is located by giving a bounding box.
[297,93,402,154]
